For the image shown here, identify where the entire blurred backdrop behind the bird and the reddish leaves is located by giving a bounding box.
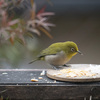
[0,0,100,69]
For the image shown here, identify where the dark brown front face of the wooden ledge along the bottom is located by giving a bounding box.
[0,85,100,100]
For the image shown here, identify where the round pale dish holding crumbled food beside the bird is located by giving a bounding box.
[47,64,100,82]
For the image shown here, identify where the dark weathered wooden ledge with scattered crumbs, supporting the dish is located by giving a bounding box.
[0,69,100,100]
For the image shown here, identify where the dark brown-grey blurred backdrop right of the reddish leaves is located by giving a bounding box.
[28,0,100,69]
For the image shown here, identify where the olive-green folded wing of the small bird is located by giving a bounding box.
[38,46,62,58]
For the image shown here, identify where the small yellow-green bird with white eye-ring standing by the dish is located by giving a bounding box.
[29,41,82,69]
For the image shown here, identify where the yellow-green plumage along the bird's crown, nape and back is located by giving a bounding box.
[38,41,78,57]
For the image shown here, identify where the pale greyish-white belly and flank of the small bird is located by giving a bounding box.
[45,51,68,66]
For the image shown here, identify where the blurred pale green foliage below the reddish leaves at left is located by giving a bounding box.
[0,37,39,68]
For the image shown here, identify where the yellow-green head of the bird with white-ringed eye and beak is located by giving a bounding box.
[65,41,82,57]
